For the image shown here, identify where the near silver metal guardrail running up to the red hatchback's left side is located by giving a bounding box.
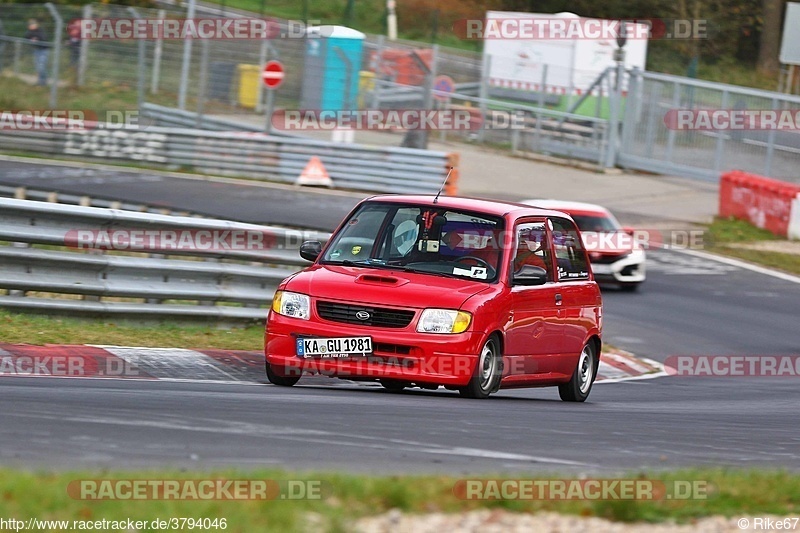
[0,198,329,319]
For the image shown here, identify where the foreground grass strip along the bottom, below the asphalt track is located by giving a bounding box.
[0,469,800,532]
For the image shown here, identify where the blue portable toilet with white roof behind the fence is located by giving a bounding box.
[300,26,364,111]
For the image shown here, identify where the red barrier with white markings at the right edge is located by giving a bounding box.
[719,170,800,239]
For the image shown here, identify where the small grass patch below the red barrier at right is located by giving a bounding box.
[705,217,800,275]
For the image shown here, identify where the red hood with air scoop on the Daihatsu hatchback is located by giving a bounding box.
[284,265,490,309]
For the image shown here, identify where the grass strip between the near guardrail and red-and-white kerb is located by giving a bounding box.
[0,310,266,352]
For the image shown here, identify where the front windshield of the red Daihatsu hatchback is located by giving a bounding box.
[322,203,503,282]
